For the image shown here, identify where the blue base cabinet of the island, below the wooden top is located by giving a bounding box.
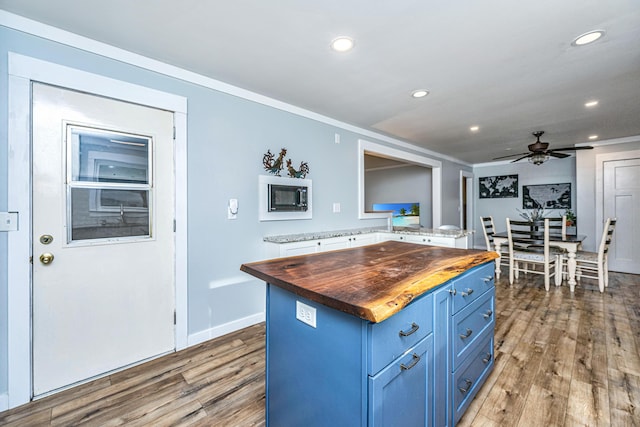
[266,262,494,427]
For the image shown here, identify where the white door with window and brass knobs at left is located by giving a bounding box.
[32,84,175,396]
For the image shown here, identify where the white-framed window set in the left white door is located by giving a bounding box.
[66,124,153,243]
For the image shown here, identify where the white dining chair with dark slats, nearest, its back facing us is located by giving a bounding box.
[507,218,562,291]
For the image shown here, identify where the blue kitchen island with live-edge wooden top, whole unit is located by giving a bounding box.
[241,241,497,427]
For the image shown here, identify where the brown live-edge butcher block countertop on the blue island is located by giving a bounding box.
[240,241,498,323]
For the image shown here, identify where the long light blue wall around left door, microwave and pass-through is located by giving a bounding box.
[0,26,470,394]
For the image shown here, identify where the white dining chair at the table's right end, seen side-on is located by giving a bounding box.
[576,218,617,292]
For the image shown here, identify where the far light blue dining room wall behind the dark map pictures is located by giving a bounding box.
[473,157,580,249]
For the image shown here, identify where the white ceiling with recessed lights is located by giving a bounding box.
[0,0,640,163]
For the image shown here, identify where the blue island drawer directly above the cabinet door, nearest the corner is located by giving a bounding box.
[367,294,433,375]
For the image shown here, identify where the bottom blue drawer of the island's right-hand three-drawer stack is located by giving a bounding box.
[452,335,493,423]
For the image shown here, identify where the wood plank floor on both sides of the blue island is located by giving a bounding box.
[0,270,640,427]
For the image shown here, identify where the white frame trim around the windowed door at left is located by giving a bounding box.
[7,52,187,408]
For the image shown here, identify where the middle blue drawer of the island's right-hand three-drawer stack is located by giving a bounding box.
[452,289,495,370]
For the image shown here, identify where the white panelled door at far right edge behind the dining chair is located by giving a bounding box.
[596,159,640,274]
